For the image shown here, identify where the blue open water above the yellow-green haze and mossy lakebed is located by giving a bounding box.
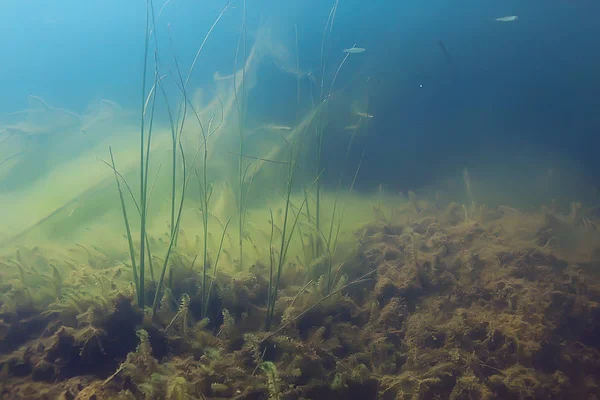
[0,0,600,205]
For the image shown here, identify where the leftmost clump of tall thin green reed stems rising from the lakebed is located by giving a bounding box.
[109,0,229,315]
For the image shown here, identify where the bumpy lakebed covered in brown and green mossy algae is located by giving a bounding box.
[0,200,600,400]
